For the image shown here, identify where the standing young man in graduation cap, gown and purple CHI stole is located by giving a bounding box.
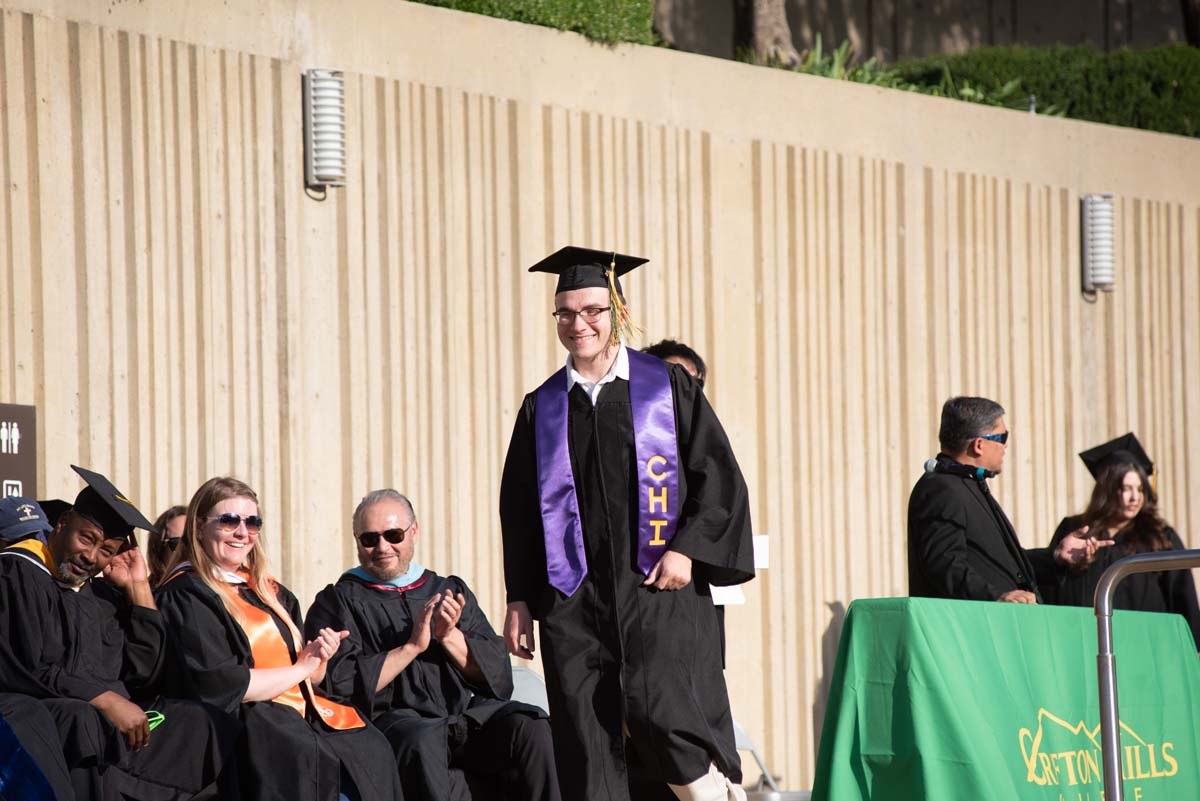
[500,247,754,801]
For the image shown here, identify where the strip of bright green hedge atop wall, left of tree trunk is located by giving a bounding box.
[416,0,659,44]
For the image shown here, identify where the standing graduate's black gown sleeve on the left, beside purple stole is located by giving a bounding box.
[500,393,547,608]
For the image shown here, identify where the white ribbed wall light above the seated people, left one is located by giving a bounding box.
[302,70,346,187]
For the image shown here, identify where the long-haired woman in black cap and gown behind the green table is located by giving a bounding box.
[1042,434,1200,649]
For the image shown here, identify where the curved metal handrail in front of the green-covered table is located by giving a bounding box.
[1096,550,1200,801]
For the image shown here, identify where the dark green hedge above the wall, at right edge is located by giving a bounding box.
[892,44,1200,137]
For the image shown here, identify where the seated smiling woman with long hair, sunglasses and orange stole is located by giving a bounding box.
[156,478,403,801]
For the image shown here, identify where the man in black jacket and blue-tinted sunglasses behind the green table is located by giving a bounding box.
[908,397,1111,603]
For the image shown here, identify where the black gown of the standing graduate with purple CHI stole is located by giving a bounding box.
[500,366,754,801]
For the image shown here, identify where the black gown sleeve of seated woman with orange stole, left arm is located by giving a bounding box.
[157,576,252,713]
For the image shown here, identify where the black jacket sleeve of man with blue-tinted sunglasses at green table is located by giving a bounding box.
[908,478,1015,601]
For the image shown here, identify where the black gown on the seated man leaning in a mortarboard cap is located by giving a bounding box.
[0,553,239,801]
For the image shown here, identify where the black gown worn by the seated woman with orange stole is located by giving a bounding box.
[157,573,403,801]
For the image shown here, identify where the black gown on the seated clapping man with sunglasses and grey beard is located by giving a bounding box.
[305,571,550,801]
